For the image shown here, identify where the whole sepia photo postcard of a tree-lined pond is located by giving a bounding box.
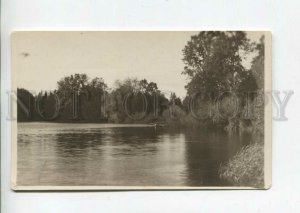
[10,31,272,190]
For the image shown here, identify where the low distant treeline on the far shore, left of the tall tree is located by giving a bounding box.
[17,77,176,123]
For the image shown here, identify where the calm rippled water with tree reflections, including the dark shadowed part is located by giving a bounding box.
[17,123,251,186]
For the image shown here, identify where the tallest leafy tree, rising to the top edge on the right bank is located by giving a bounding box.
[182,31,257,129]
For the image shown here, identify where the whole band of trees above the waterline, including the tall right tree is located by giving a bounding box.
[17,32,264,131]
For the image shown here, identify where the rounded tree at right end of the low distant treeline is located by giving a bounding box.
[108,78,168,122]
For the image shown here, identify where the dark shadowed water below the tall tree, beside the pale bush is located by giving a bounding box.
[185,131,251,186]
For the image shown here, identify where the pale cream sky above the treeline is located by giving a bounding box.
[12,31,263,97]
